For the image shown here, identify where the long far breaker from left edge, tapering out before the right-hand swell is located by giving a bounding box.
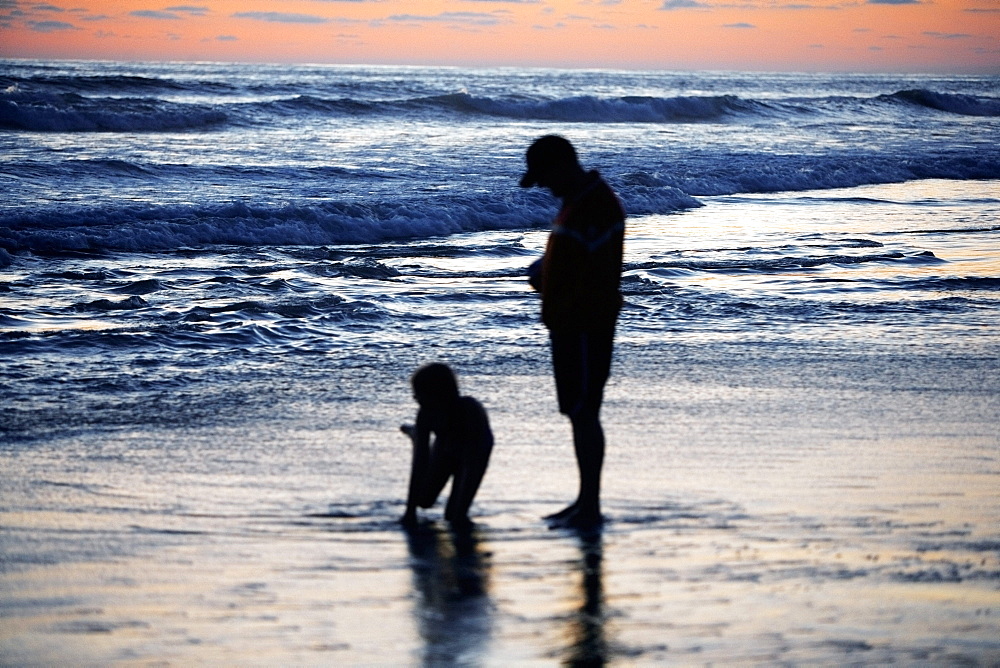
[0,75,775,126]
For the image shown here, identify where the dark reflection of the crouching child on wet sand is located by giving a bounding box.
[406,524,492,665]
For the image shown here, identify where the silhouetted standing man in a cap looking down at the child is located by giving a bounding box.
[521,135,625,528]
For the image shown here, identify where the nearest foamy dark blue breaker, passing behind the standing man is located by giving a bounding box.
[0,155,1000,256]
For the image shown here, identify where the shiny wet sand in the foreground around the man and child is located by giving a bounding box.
[0,337,1000,665]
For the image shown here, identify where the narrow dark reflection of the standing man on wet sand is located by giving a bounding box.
[566,531,608,666]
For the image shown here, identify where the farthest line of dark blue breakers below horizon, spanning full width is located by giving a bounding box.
[7,76,1000,132]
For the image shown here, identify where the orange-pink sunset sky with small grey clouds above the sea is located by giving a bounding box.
[0,0,1000,73]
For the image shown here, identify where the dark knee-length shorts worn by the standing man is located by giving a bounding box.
[549,327,615,418]
